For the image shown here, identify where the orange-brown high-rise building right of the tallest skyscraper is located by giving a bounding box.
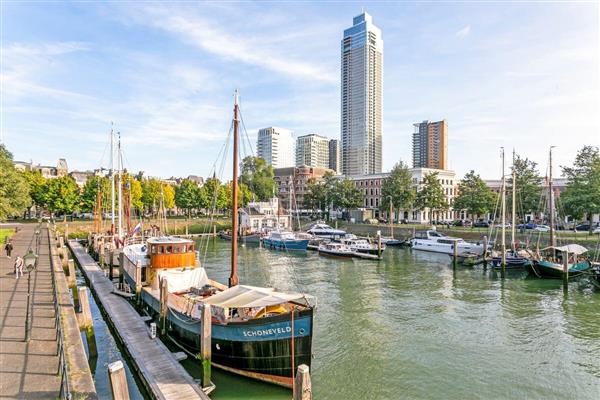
[413,120,448,170]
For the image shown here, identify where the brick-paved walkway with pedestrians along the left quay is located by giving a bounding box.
[0,224,60,399]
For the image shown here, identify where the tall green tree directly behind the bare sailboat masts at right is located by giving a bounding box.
[506,154,542,214]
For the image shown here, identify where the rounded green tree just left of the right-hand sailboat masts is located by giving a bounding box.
[453,170,496,217]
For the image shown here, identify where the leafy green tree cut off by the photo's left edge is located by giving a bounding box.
[0,144,31,220]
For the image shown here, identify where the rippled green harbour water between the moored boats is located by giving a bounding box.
[185,240,600,400]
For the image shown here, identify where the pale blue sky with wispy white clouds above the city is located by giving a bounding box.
[0,0,600,179]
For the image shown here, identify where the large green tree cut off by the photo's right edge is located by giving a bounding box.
[560,146,600,231]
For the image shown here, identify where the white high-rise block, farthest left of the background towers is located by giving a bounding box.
[256,127,295,168]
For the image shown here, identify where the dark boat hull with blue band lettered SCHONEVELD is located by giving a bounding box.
[142,292,313,387]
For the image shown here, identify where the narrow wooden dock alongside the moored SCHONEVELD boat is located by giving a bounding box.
[69,240,209,400]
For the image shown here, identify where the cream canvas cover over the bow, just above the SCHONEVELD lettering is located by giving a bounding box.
[204,285,306,308]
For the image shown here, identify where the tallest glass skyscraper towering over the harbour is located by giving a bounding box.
[341,13,383,175]
